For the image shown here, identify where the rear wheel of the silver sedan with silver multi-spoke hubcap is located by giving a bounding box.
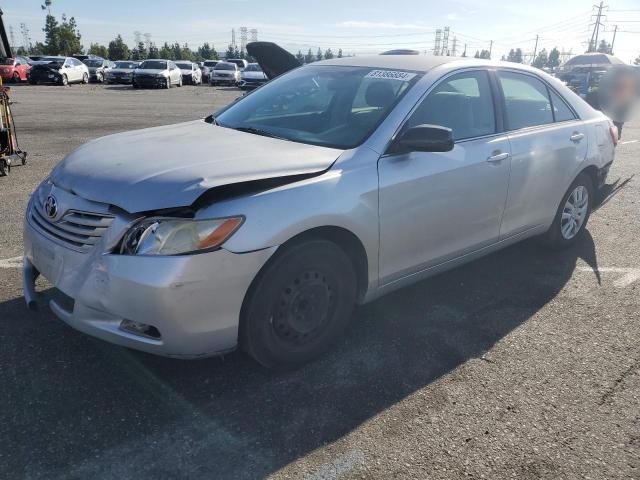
[543,173,595,250]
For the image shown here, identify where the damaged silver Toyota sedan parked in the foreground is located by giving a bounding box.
[24,55,617,368]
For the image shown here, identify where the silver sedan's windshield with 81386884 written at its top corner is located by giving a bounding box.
[216,65,419,149]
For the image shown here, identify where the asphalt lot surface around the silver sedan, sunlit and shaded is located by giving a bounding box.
[0,85,640,480]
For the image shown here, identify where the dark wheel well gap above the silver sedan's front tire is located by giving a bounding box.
[280,226,369,301]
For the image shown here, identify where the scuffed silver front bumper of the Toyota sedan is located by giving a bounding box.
[23,208,277,358]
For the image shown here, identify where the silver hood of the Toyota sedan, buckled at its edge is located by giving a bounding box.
[50,120,342,213]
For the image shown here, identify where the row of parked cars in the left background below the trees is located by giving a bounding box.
[0,55,267,89]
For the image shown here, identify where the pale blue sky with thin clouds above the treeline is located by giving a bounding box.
[0,0,640,62]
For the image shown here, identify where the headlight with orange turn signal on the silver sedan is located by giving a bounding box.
[120,217,244,255]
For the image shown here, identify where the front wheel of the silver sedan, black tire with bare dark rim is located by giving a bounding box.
[240,240,357,370]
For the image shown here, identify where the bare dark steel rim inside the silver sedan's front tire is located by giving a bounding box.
[271,270,334,345]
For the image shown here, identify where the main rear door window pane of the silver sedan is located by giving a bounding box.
[498,72,553,130]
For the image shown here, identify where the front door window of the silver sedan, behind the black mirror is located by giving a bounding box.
[405,71,496,140]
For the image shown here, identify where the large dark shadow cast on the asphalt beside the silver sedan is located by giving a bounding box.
[0,232,597,479]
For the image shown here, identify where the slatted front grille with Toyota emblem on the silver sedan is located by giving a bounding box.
[29,198,114,253]
